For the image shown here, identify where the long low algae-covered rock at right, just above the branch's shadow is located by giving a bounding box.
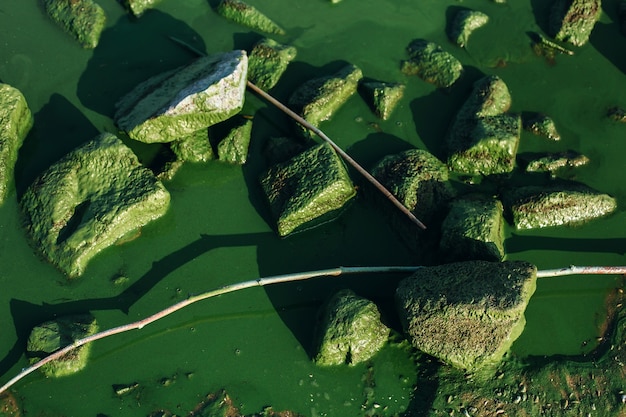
[504,182,617,229]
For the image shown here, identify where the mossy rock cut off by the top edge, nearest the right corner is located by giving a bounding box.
[550,0,602,46]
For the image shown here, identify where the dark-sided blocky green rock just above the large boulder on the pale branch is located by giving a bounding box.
[439,194,505,261]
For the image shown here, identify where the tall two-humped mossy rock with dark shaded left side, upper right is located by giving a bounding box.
[447,76,521,175]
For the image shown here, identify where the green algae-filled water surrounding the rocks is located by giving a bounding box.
[0,0,626,416]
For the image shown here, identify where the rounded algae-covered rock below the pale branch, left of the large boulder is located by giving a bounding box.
[315,290,390,365]
